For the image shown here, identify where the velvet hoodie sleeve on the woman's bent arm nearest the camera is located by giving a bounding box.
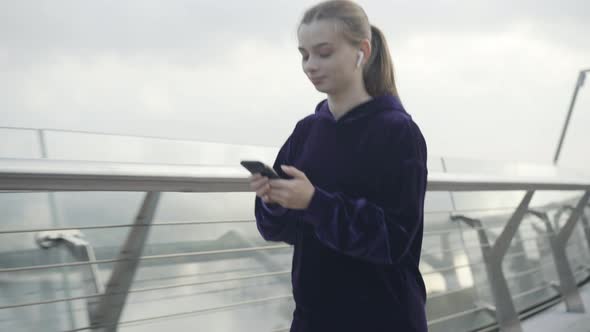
[302,120,428,264]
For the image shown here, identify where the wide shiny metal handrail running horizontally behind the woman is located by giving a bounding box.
[0,159,590,192]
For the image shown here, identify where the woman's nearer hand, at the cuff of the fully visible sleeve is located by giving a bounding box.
[268,165,315,210]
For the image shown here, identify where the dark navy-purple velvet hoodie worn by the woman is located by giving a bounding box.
[255,95,428,332]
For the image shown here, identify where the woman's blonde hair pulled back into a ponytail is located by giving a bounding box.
[299,0,398,97]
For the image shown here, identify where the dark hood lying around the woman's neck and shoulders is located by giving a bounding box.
[315,95,405,123]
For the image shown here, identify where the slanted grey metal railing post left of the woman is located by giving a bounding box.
[90,192,160,332]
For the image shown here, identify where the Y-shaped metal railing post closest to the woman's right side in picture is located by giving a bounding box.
[451,190,535,332]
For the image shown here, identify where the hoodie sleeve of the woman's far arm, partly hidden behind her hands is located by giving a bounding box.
[254,120,299,244]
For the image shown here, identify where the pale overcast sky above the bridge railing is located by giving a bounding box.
[0,0,590,168]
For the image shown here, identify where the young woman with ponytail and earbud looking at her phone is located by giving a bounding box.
[250,1,428,332]
